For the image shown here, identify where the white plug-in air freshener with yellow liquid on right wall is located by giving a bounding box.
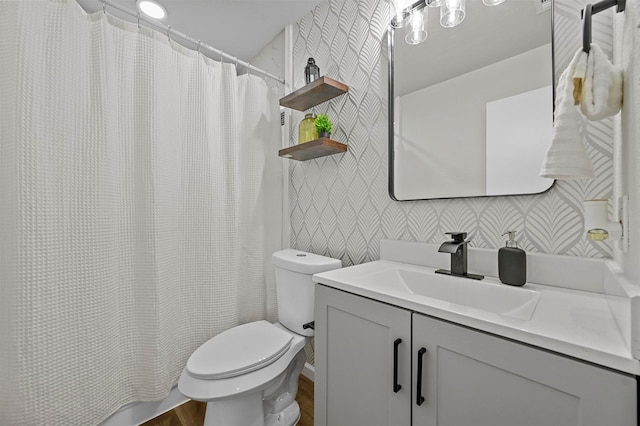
[583,195,629,253]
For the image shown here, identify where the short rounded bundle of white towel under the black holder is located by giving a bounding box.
[580,43,622,121]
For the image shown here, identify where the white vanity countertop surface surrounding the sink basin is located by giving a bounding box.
[313,260,640,375]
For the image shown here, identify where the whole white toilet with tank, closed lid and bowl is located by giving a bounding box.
[178,249,342,426]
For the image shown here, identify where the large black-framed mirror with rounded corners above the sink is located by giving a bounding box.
[388,0,553,200]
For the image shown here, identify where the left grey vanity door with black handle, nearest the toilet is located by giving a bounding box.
[314,285,411,426]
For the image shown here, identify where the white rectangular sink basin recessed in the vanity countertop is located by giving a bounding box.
[360,267,540,321]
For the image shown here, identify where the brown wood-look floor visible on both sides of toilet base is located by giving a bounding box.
[143,375,313,426]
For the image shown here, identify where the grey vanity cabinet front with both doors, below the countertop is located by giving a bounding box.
[315,285,637,426]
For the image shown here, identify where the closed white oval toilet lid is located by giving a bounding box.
[187,321,293,379]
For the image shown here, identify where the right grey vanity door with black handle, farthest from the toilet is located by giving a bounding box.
[412,314,636,426]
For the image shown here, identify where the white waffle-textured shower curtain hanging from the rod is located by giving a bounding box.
[0,0,282,425]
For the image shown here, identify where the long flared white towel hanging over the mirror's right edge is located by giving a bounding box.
[540,49,594,180]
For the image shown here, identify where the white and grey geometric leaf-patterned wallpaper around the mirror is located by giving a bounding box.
[289,0,613,266]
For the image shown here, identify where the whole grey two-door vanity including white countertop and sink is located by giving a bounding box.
[314,242,640,426]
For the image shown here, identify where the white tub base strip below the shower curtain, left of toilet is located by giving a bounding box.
[100,386,189,426]
